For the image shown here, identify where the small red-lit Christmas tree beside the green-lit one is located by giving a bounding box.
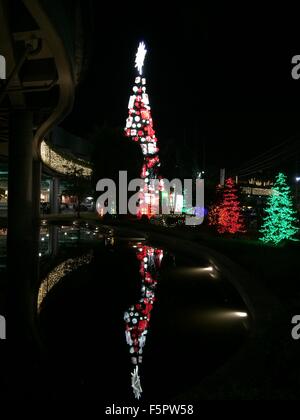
[217,178,245,233]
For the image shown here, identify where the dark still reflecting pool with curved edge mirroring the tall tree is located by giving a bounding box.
[38,225,250,403]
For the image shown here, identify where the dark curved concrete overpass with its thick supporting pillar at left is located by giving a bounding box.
[0,0,90,356]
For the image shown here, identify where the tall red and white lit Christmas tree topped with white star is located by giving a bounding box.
[125,42,160,216]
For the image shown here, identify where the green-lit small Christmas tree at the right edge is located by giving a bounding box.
[259,173,299,245]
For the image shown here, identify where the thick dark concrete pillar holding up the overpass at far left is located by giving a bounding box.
[7,110,37,353]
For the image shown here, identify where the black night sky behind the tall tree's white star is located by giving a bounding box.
[65,2,300,167]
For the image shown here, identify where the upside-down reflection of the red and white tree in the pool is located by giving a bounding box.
[124,245,163,399]
